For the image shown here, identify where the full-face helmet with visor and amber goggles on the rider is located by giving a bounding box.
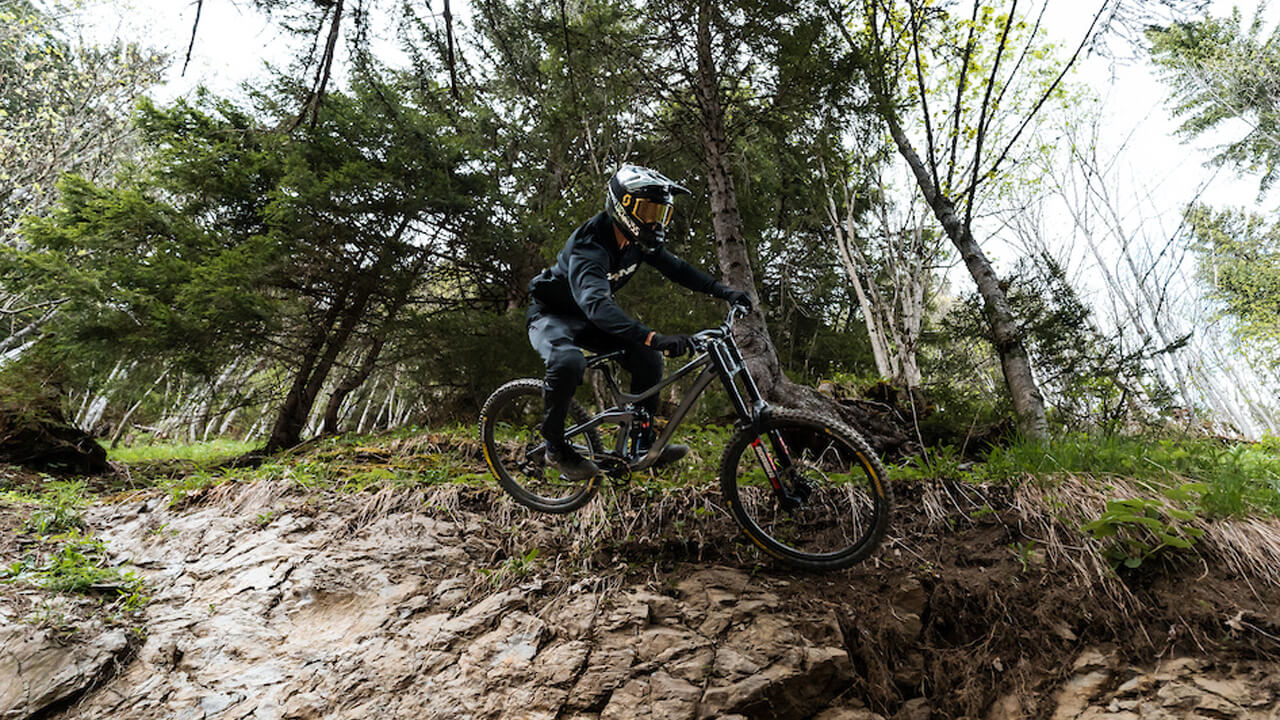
[604,165,689,252]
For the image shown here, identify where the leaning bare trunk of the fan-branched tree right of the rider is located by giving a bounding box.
[884,110,1048,438]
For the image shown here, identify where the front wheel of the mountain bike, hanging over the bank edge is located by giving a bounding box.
[721,410,892,570]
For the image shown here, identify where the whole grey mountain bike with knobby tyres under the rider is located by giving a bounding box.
[480,306,892,570]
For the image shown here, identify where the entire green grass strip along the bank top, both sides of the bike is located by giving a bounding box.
[94,423,1280,524]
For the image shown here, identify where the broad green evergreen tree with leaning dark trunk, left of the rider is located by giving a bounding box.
[8,77,484,447]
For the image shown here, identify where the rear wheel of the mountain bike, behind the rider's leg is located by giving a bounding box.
[480,379,602,512]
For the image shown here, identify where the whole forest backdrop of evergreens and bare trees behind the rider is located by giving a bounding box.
[0,0,1280,471]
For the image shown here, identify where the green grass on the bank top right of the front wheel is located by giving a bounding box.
[891,433,1280,518]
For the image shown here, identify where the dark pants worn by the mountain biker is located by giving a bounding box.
[527,301,662,445]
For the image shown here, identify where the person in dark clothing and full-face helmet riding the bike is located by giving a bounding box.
[527,165,751,480]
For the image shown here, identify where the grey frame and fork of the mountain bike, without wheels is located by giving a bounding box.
[564,309,790,471]
